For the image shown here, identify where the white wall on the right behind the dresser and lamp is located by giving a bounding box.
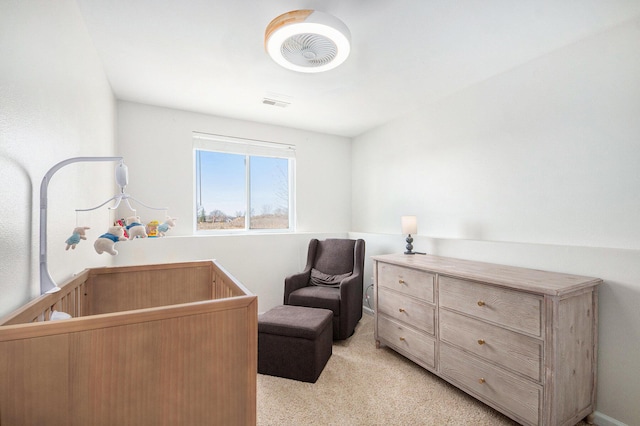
[350,15,640,424]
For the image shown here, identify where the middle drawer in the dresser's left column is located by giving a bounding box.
[378,288,436,336]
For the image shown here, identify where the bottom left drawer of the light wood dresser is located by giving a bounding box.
[377,315,436,368]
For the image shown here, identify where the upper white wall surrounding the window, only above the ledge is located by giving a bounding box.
[118,101,351,235]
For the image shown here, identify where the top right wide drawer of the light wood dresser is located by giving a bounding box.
[439,276,543,336]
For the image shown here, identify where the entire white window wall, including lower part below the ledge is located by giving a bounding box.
[114,102,351,312]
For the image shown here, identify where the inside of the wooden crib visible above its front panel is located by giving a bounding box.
[0,260,251,326]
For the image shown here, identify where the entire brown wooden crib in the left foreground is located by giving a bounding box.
[0,261,258,426]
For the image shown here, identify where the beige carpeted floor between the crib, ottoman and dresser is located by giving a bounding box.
[258,315,592,426]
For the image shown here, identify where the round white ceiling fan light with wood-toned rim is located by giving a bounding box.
[264,9,351,73]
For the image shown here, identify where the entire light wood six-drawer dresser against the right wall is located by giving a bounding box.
[373,254,602,426]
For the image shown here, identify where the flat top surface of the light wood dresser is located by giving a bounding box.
[373,254,602,296]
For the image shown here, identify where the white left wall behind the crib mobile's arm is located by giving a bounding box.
[0,0,115,316]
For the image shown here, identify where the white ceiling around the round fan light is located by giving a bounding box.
[77,0,640,137]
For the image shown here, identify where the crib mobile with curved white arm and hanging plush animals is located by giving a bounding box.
[40,157,176,294]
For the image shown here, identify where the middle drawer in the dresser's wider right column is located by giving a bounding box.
[440,309,542,382]
